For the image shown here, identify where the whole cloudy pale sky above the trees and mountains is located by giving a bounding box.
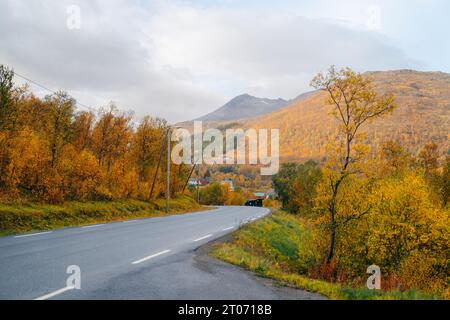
[0,0,450,122]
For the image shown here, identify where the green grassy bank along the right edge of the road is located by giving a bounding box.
[211,212,442,300]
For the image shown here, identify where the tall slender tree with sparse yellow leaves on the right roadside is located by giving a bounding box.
[311,67,395,264]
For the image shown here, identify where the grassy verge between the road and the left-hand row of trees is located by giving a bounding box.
[0,196,205,236]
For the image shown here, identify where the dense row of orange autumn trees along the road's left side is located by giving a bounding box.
[0,65,190,203]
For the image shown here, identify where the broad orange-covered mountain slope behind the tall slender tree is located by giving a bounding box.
[241,70,450,160]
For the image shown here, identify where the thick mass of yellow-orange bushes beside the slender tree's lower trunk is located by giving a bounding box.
[317,171,450,292]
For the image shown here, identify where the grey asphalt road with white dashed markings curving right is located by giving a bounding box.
[0,207,324,300]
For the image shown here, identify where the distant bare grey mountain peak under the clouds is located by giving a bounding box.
[196,94,290,121]
